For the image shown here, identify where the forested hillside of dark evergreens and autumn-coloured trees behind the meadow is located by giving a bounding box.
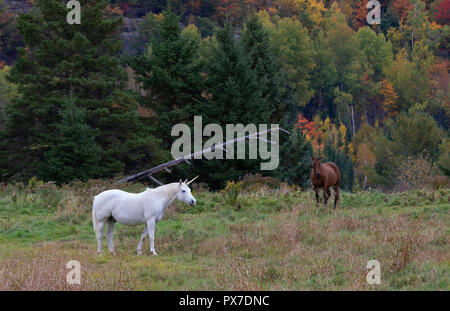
[0,0,450,191]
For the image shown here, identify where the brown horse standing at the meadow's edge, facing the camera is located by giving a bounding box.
[311,158,341,208]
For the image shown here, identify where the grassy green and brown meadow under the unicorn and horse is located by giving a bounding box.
[0,180,450,290]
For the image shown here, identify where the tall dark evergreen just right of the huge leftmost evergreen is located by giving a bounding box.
[131,8,204,149]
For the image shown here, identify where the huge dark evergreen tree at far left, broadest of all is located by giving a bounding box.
[2,0,163,180]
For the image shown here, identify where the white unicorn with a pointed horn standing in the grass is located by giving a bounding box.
[92,176,198,256]
